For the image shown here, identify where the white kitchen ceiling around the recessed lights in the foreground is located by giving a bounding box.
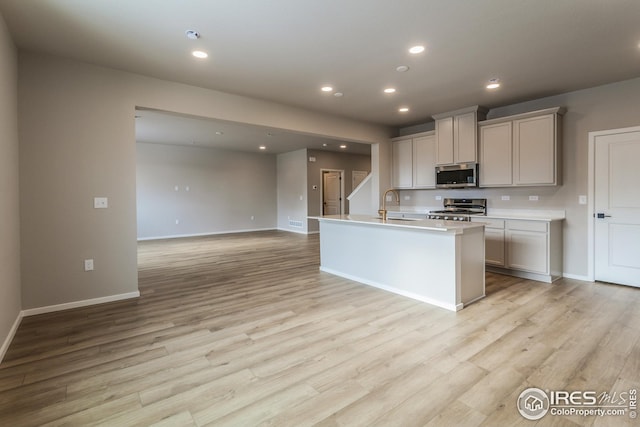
[0,0,640,152]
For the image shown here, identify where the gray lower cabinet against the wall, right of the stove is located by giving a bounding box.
[472,218,562,283]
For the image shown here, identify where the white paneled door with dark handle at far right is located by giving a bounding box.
[593,130,640,287]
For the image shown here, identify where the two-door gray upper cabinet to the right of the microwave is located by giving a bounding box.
[479,108,565,187]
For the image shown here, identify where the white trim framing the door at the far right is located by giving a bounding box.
[586,126,640,282]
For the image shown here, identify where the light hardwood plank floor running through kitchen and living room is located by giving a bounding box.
[0,231,640,427]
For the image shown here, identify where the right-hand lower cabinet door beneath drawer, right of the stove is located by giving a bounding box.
[506,230,549,274]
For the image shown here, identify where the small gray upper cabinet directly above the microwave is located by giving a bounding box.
[433,105,487,165]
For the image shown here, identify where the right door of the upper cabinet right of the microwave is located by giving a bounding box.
[513,114,556,185]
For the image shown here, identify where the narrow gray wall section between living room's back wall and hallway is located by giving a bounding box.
[277,149,307,233]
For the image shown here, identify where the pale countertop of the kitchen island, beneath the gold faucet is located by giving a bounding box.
[316,215,484,233]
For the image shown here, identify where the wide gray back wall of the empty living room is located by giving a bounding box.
[136,142,277,239]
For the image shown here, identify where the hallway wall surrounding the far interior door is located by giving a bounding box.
[305,150,371,232]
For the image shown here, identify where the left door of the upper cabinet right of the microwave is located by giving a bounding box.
[478,122,513,187]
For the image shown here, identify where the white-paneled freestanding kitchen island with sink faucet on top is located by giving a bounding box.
[317,215,485,311]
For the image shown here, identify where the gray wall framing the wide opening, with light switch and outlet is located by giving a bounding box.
[14,52,391,309]
